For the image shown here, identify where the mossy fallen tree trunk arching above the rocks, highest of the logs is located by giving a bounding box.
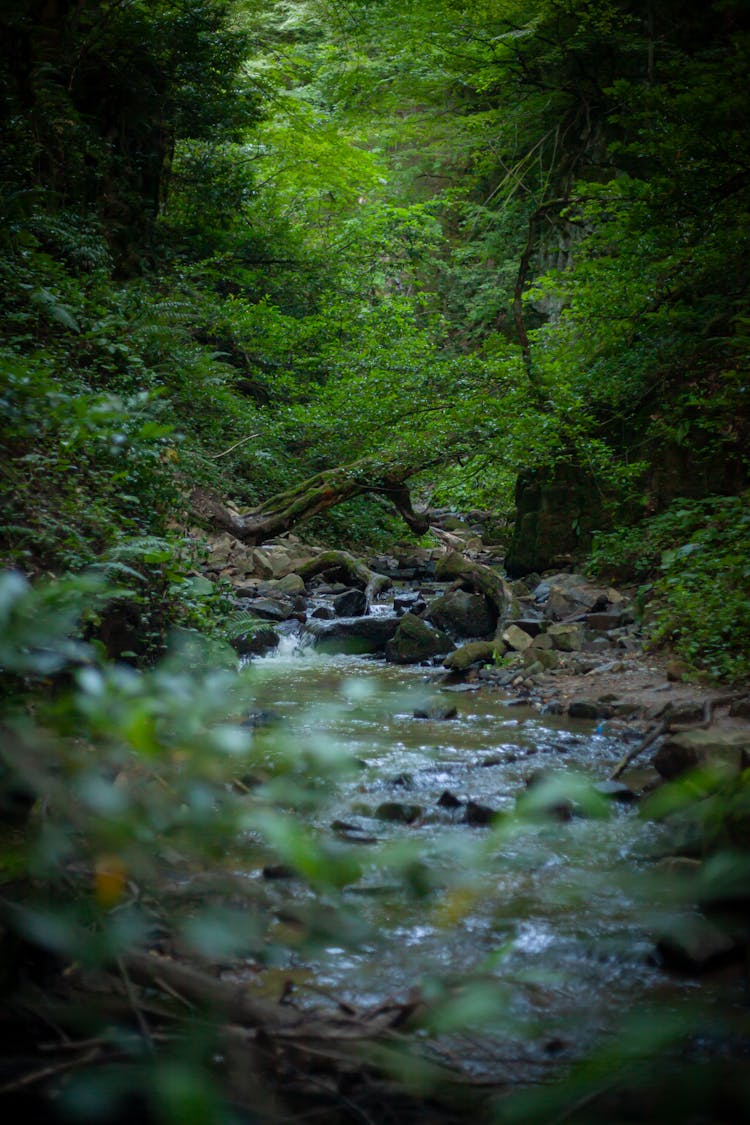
[191,457,430,547]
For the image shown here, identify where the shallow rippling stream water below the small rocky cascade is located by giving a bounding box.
[239,594,737,1079]
